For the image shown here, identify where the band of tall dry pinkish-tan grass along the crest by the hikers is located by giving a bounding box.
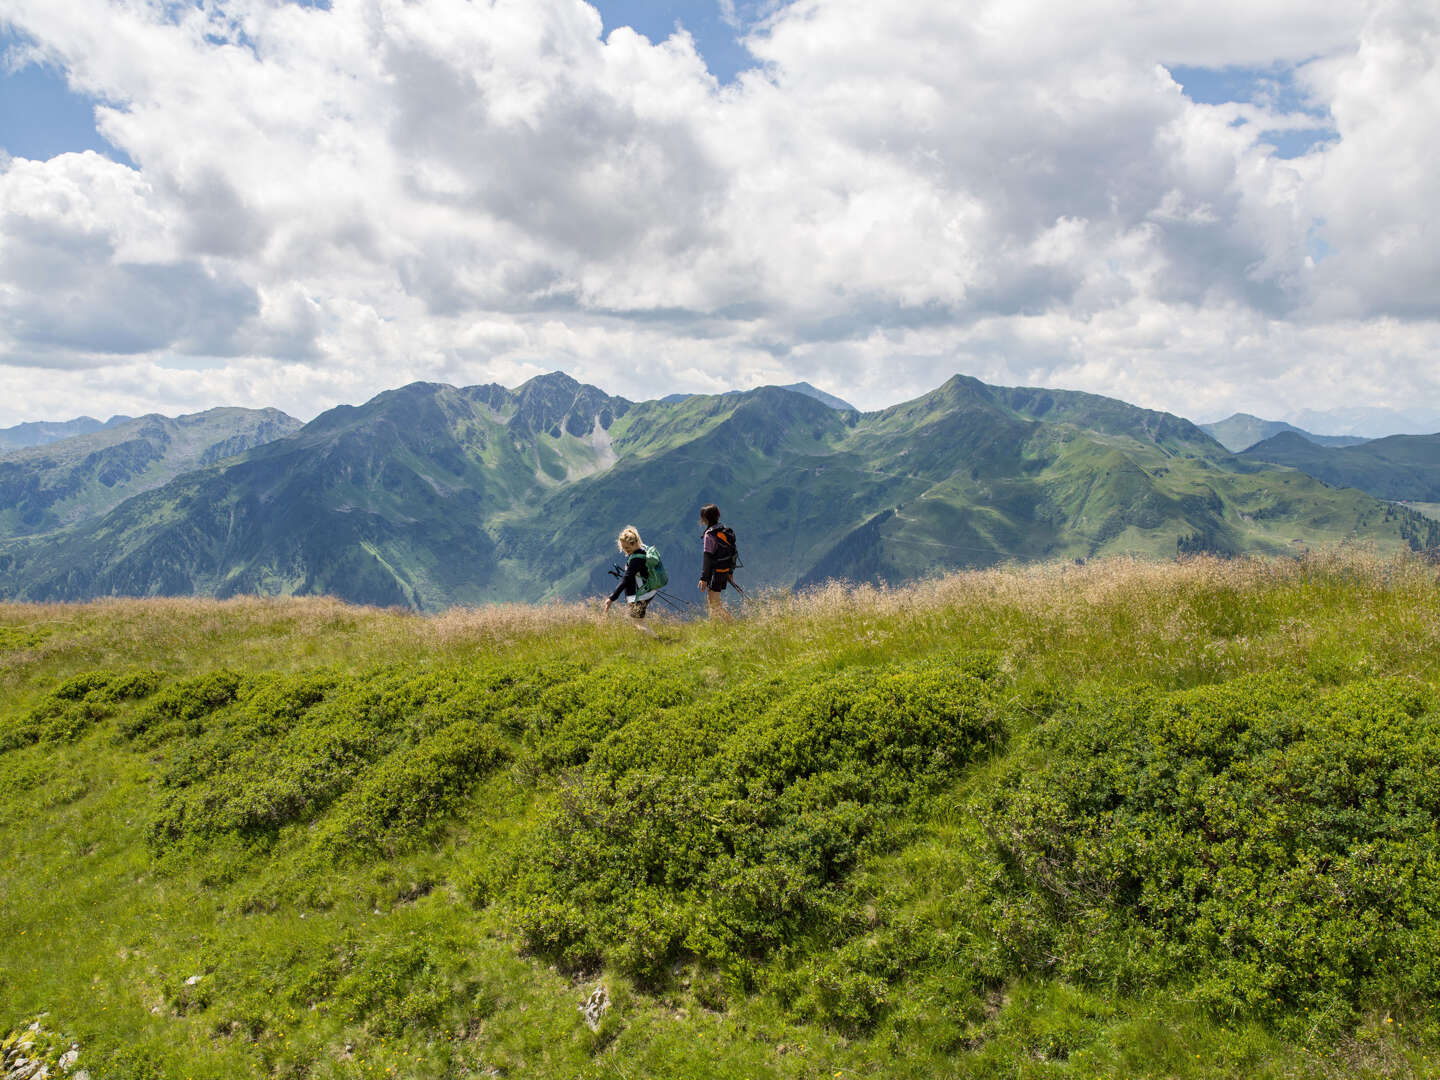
[0,547,1440,688]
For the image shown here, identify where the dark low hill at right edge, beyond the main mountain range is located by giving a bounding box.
[1244,433,1440,503]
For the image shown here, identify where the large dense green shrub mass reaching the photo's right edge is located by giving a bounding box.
[976,675,1440,1034]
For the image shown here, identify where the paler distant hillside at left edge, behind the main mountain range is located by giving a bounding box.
[0,409,301,539]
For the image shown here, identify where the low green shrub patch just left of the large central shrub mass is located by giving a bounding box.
[148,668,535,852]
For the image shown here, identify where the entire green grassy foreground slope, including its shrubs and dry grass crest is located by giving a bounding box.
[0,550,1440,1080]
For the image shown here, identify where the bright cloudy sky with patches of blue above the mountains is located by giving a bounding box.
[0,0,1440,425]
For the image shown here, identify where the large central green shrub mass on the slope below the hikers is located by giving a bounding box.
[516,664,1004,984]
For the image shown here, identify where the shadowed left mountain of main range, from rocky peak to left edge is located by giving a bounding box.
[0,377,628,608]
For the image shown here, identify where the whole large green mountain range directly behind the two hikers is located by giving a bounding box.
[0,373,1440,611]
